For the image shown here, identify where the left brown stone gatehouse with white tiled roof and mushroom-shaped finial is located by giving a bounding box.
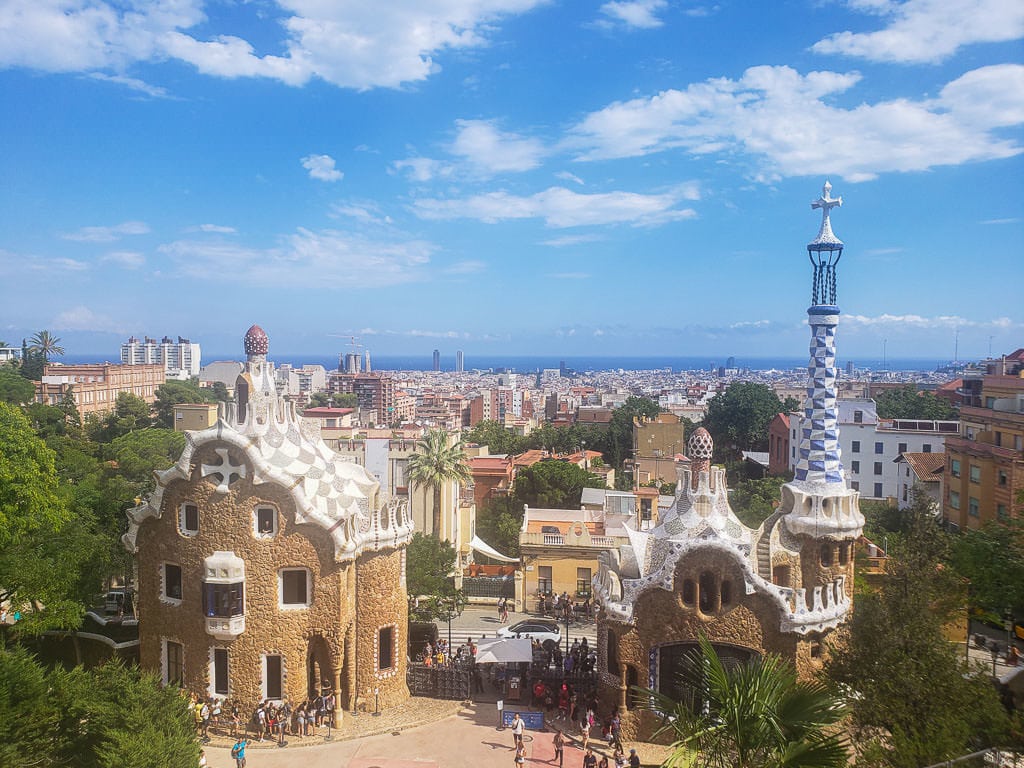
[125,330,413,725]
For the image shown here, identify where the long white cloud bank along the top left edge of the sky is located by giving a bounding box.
[0,0,543,89]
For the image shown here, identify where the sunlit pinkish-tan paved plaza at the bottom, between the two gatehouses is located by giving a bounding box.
[200,699,665,768]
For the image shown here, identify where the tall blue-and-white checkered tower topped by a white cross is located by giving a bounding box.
[783,181,864,539]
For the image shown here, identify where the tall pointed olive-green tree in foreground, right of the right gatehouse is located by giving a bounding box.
[826,495,1009,768]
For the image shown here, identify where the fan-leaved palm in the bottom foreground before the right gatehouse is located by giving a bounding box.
[637,637,849,768]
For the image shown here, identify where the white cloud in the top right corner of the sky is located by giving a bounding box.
[811,0,1024,62]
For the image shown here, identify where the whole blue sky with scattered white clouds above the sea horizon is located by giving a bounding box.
[0,0,1024,358]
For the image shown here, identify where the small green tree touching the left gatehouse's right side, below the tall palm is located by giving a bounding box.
[406,531,466,622]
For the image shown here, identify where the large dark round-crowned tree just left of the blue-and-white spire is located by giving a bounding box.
[702,382,799,460]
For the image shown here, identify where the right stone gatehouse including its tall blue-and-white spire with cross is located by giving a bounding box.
[594,183,864,738]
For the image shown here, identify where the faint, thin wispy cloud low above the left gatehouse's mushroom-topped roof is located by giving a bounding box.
[160,228,436,287]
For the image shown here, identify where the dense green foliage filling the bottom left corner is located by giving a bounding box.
[0,649,200,768]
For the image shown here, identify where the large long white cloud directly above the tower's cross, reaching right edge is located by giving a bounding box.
[570,65,1024,181]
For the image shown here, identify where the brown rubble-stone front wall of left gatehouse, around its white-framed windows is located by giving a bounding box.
[136,443,354,714]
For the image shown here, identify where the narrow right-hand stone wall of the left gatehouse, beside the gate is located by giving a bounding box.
[355,551,409,711]
